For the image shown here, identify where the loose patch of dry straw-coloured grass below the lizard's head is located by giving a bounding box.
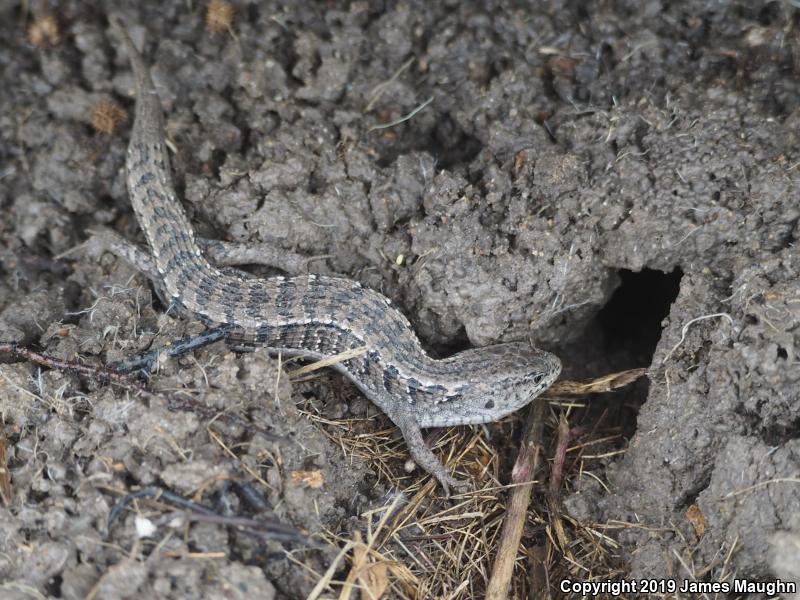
[296,372,642,599]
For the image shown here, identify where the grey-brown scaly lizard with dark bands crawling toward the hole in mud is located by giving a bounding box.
[112,20,561,492]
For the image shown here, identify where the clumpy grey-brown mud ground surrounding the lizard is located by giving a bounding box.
[0,0,800,598]
